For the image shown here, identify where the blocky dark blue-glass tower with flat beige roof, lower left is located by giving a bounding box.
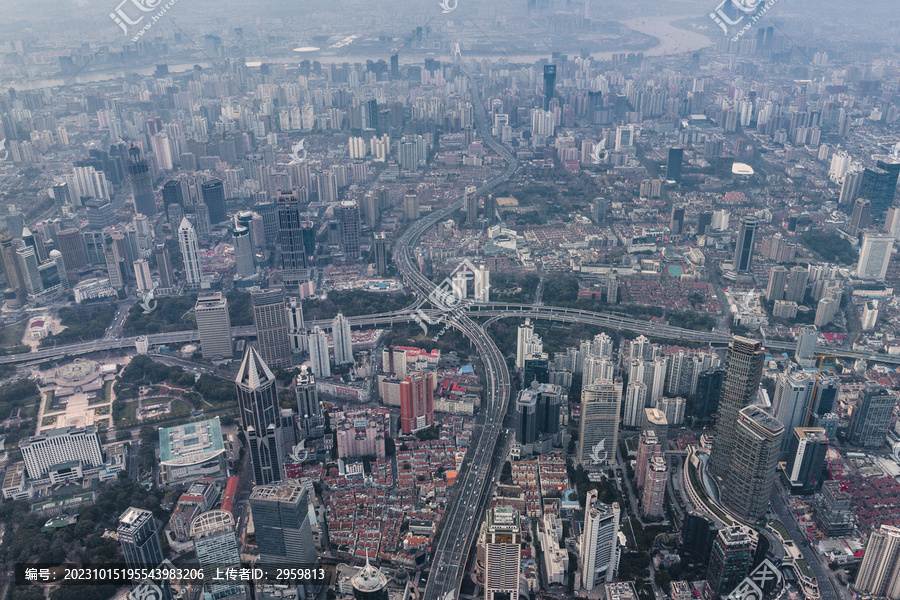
[250,480,316,565]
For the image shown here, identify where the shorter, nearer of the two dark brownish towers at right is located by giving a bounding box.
[716,406,784,521]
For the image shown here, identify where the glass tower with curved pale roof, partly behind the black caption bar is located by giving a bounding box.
[190,510,248,600]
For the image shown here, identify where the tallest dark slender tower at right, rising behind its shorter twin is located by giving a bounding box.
[710,335,766,478]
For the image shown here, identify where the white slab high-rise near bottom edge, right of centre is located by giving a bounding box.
[581,490,620,591]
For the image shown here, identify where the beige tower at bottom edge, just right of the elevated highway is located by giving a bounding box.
[484,506,522,600]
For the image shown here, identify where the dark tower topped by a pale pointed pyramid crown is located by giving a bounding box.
[235,346,284,486]
